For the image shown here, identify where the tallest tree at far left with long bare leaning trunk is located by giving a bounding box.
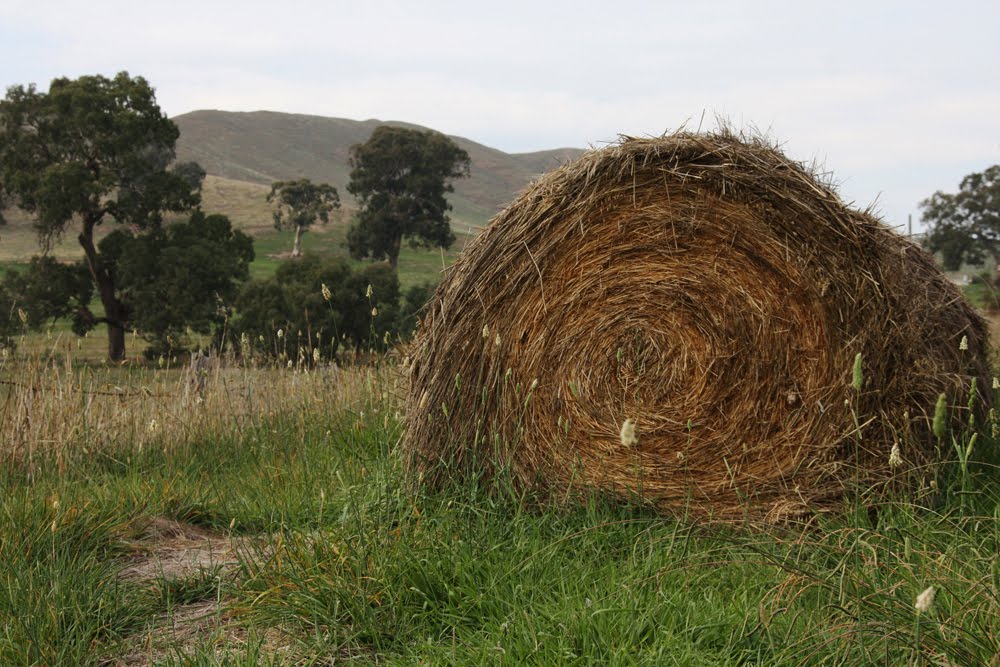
[0,72,204,360]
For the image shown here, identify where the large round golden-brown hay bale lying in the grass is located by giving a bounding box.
[403,132,989,520]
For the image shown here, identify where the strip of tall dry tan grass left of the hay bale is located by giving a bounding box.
[0,353,386,469]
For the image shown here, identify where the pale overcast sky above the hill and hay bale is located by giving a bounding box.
[0,0,1000,230]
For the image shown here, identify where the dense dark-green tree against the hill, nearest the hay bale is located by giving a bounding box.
[347,125,469,268]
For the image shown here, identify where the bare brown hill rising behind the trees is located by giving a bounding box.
[173,111,583,227]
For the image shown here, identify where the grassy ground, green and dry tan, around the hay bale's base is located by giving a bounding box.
[0,353,1000,665]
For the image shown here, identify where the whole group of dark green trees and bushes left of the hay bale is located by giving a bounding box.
[0,72,460,362]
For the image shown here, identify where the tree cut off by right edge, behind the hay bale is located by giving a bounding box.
[920,165,1000,271]
